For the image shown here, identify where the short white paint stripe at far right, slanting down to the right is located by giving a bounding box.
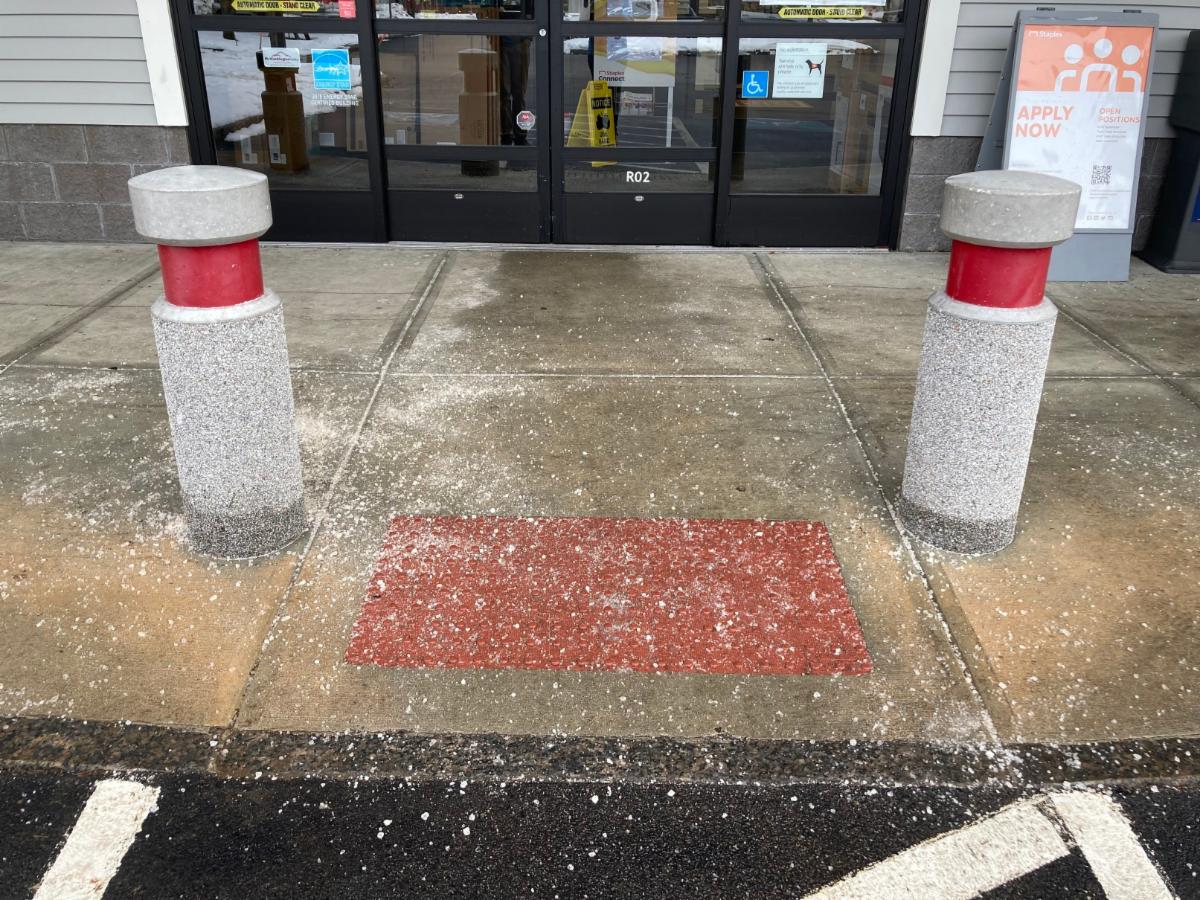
[1050,792,1172,900]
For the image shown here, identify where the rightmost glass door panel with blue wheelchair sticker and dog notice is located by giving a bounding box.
[716,0,920,247]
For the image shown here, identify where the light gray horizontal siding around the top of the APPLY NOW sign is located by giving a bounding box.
[942,0,1200,138]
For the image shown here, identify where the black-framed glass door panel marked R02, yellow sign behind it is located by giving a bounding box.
[557,35,721,244]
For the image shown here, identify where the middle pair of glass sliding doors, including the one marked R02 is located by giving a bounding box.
[377,0,721,244]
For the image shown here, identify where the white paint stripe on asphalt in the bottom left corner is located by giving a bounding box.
[34,780,158,900]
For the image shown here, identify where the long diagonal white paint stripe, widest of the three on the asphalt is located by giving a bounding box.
[809,799,1070,900]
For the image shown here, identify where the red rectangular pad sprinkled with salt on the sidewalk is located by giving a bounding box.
[346,516,871,676]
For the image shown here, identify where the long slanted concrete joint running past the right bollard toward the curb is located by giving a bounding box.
[750,253,1002,745]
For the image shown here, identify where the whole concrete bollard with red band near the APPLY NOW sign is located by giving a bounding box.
[899,170,1080,553]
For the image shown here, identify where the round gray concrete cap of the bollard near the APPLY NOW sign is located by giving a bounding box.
[942,169,1080,247]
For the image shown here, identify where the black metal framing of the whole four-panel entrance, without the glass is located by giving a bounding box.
[172,0,928,247]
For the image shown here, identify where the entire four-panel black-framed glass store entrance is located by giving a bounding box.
[175,0,917,246]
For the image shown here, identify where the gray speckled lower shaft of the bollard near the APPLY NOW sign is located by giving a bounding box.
[899,292,1058,553]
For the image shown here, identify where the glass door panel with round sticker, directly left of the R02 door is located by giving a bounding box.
[376,0,551,242]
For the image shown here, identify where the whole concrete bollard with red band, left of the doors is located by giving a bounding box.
[130,166,305,558]
